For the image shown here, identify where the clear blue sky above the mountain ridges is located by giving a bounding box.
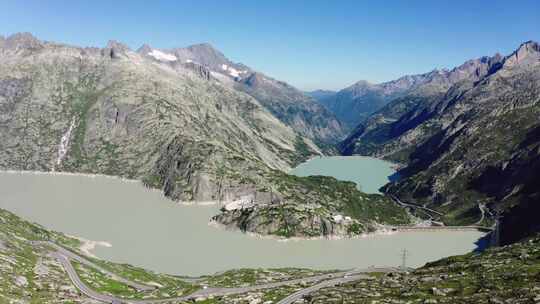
[0,0,540,90]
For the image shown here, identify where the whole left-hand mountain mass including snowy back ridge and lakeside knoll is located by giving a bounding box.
[0,33,396,236]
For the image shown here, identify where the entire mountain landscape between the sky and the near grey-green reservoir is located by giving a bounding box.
[0,33,540,242]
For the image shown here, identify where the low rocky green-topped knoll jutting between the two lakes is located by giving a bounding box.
[214,174,410,237]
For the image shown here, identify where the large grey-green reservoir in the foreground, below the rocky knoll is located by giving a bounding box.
[0,158,482,275]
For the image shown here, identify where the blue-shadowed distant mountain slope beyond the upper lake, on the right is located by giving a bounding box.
[340,54,502,157]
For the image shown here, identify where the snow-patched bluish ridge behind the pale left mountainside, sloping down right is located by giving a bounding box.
[138,43,345,148]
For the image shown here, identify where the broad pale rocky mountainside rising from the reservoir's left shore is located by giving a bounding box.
[0,34,318,200]
